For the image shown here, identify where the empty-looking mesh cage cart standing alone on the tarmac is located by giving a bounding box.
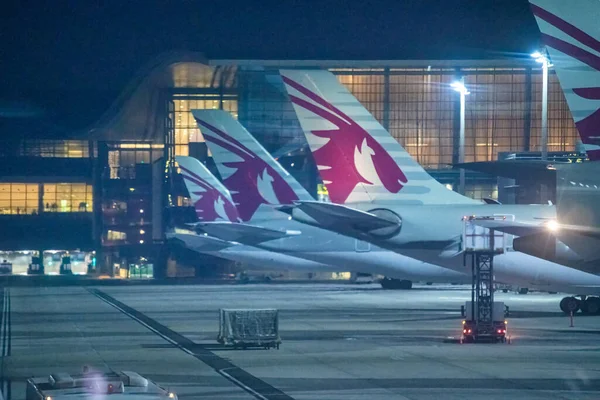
[217,309,281,349]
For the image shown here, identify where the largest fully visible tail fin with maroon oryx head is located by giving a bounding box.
[280,70,474,204]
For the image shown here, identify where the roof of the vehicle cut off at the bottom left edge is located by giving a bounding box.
[25,370,177,400]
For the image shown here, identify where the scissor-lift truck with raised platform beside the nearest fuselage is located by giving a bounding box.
[462,216,507,342]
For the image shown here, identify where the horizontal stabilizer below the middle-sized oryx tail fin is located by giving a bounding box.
[195,222,301,245]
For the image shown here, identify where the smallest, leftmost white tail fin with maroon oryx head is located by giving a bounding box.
[175,156,239,222]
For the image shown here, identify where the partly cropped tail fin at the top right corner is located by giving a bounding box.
[529,0,600,161]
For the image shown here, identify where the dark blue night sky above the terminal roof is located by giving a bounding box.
[0,0,538,130]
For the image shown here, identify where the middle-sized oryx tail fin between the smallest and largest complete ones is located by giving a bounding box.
[192,110,312,221]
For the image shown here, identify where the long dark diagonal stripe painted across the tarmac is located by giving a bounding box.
[87,289,294,400]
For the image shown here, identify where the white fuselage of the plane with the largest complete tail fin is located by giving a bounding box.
[290,203,600,294]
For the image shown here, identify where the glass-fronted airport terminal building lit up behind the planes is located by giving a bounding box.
[0,53,582,277]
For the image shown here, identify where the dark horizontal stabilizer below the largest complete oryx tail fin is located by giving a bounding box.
[290,201,398,233]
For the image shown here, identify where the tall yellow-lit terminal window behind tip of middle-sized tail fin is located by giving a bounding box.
[172,95,238,156]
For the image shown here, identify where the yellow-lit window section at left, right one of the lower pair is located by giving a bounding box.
[42,183,93,212]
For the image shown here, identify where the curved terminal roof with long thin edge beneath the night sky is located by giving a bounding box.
[0,51,535,141]
